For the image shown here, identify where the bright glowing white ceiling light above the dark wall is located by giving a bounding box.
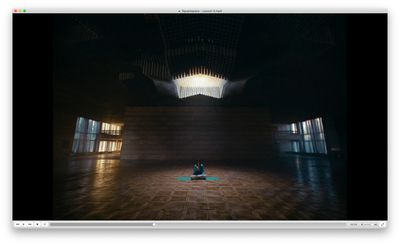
[174,74,227,99]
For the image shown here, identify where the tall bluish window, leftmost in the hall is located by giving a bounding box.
[72,117,100,153]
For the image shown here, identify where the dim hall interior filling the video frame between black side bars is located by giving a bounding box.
[53,14,347,220]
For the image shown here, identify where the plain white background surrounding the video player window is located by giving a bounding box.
[0,0,400,245]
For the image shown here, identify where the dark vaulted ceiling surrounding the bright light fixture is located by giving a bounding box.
[54,14,346,120]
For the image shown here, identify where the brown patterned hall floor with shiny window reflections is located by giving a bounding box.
[54,155,346,220]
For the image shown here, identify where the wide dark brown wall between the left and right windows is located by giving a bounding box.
[121,107,273,160]
